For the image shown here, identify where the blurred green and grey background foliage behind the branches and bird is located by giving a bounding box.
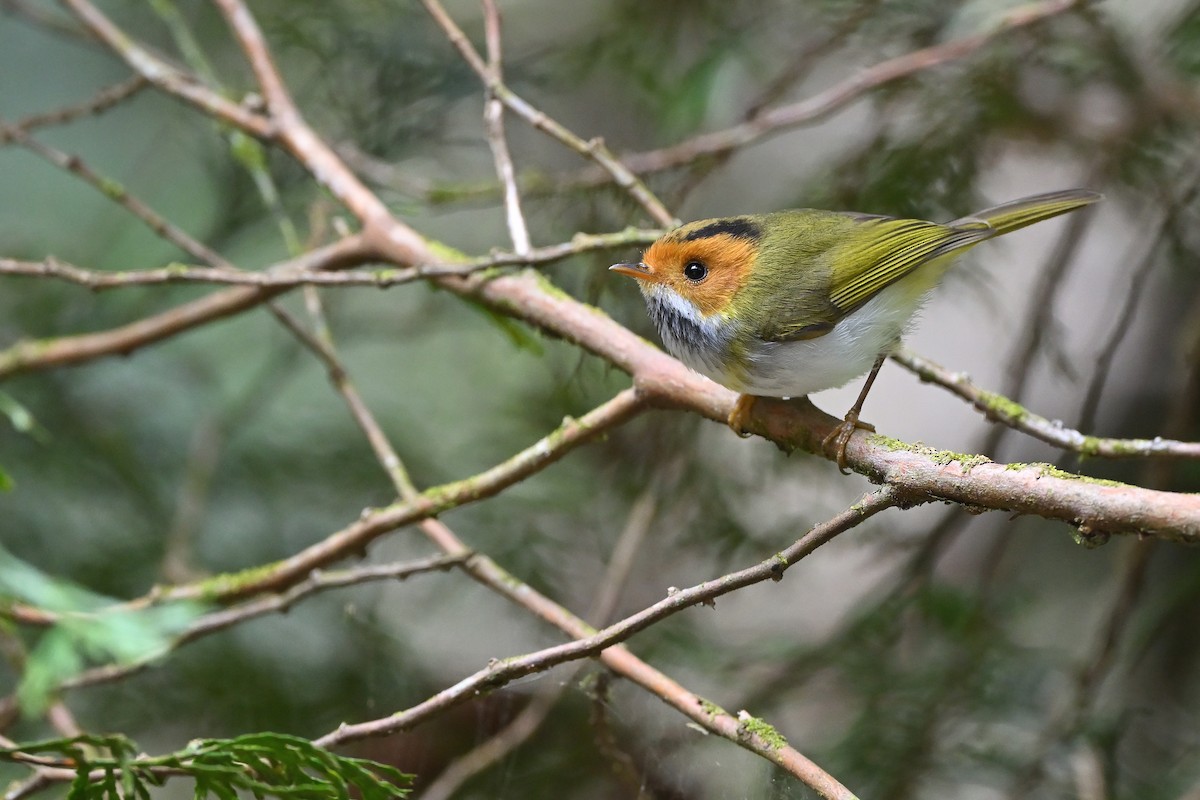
[0,0,1200,800]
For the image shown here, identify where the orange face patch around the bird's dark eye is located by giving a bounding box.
[642,234,758,317]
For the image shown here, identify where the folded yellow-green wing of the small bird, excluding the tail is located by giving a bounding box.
[763,215,996,342]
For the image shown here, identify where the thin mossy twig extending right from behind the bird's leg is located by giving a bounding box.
[892,348,1200,458]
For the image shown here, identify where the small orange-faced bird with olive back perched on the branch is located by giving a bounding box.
[610,190,1102,471]
